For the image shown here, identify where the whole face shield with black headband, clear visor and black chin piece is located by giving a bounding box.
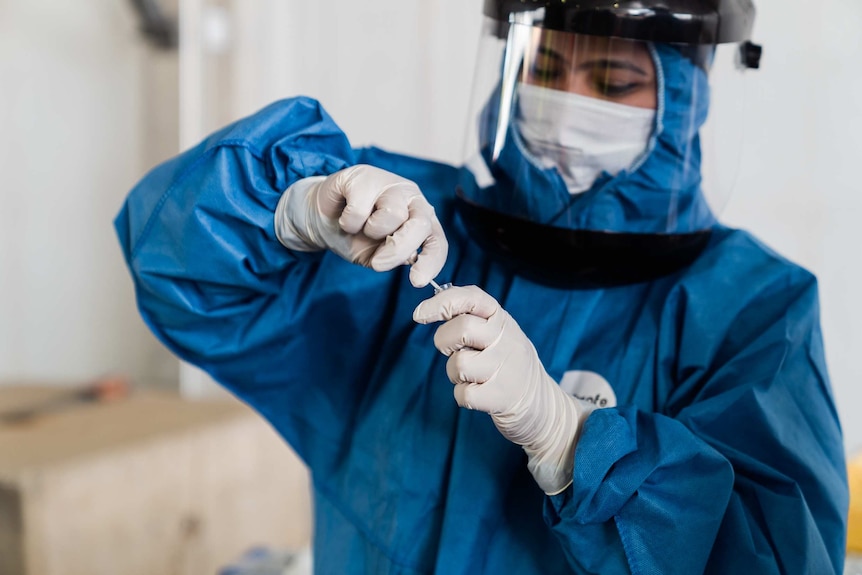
[458,0,759,287]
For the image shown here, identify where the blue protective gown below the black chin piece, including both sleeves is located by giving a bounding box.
[115,98,848,575]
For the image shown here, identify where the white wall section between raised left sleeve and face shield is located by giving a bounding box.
[201,0,483,162]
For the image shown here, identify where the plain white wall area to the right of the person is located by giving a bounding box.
[725,0,862,460]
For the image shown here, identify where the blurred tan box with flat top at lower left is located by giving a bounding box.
[0,386,311,575]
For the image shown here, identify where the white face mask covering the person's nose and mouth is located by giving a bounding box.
[515,84,655,194]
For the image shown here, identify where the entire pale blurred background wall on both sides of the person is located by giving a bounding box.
[0,0,862,451]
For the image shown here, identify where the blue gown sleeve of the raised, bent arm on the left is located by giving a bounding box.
[115,98,402,468]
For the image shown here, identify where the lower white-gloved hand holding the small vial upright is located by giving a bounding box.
[413,286,592,495]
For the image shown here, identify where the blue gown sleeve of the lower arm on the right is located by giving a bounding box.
[545,237,848,575]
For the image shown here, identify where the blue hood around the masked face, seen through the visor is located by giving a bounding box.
[460,44,716,234]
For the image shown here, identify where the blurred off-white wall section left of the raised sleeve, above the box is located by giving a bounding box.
[0,0,177,390]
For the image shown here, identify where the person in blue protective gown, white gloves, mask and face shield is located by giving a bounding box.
[115,0,847,575]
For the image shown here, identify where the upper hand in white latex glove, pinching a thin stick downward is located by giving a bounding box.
[275,165,449,288]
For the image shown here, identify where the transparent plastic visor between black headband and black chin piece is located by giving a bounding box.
[459,19,744,234]
